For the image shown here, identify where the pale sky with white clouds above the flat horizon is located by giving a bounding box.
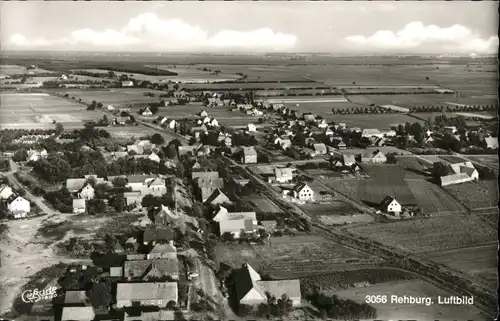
[0,1,498,54]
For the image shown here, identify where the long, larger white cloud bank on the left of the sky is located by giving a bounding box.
[10,13,297,50]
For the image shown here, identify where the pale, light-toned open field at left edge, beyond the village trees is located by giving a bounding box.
[0,93,102,129]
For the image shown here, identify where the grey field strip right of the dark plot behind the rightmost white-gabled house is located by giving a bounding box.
[406,179,467,216]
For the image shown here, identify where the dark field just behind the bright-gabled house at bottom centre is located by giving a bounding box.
[214,235,381,277]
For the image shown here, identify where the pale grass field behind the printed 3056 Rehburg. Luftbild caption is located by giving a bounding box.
[335,280,491,321]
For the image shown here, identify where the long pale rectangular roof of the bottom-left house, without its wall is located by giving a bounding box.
[116,282,177,302]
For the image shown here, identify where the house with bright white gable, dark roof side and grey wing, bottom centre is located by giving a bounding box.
[234,263,302,307]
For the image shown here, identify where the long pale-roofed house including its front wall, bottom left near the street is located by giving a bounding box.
[115,282,178,306]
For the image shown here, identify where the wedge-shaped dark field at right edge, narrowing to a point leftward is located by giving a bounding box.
[419,243,498,290]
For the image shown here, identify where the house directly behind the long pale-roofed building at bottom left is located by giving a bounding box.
[123,256,179,281]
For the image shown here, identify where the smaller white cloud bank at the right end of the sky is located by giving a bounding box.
[345,21,498,53]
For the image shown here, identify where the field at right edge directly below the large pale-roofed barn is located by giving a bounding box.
[444,180,498,210]
